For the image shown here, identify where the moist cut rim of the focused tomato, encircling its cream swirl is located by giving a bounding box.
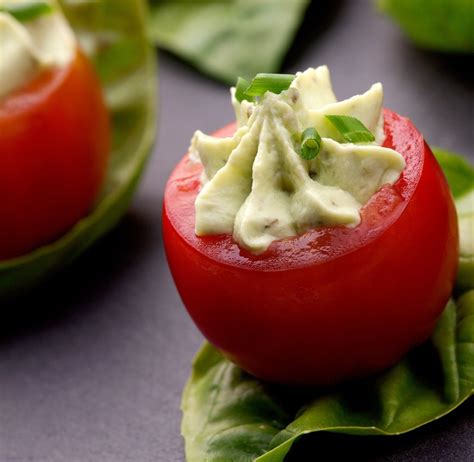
[163,109,426,273]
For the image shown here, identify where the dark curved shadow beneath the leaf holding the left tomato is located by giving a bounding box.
[0,213,159,345]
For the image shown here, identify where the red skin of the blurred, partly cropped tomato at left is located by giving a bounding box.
[0,50,110,259]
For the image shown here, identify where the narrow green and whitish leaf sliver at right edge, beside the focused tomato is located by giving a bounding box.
[433,148,474,291]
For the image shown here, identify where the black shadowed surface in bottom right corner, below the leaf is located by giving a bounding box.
[285,399,474,462]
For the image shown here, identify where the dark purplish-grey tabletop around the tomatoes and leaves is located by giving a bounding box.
[0,0,474,462]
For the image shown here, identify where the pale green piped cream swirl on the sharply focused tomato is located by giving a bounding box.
[190,66,405,254]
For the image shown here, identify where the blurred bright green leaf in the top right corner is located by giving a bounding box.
[377,0,474,53]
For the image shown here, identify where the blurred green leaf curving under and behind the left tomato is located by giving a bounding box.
[0,0,156,297]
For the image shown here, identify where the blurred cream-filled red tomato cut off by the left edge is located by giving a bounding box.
[0,1,109,259]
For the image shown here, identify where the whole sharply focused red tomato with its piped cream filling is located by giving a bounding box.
[163,68,458,384]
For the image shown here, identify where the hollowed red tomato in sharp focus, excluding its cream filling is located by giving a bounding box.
[163,110,458,384]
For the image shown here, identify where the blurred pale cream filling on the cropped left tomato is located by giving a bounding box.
[0,0,76,99]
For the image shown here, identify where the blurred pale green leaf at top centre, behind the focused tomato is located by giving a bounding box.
[149,0,309,84]
